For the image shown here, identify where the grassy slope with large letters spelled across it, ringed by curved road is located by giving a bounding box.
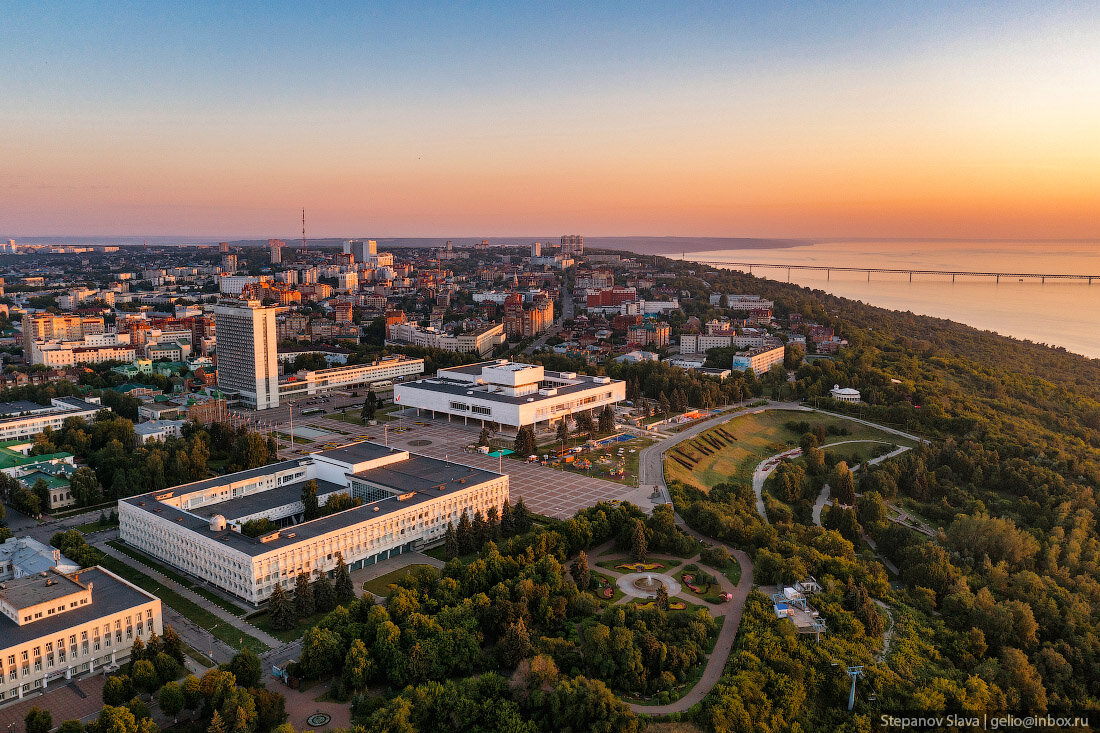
[664,409,912,491]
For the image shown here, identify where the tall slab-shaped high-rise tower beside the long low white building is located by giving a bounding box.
[213,300,278,409]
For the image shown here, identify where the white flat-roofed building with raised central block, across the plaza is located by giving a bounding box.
[394,359,626,428]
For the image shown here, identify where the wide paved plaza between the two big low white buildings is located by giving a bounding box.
[255,407,653,518]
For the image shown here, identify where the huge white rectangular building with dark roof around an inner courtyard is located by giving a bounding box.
[119,442,508,604]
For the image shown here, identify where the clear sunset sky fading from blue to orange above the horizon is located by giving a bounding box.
[0,1,1100,239]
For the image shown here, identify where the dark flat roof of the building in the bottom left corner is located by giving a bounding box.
[0,566,156,647]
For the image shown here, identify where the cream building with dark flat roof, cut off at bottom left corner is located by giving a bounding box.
[0,567,164,705]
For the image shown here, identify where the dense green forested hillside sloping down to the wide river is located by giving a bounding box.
[655,262,1100,731]
